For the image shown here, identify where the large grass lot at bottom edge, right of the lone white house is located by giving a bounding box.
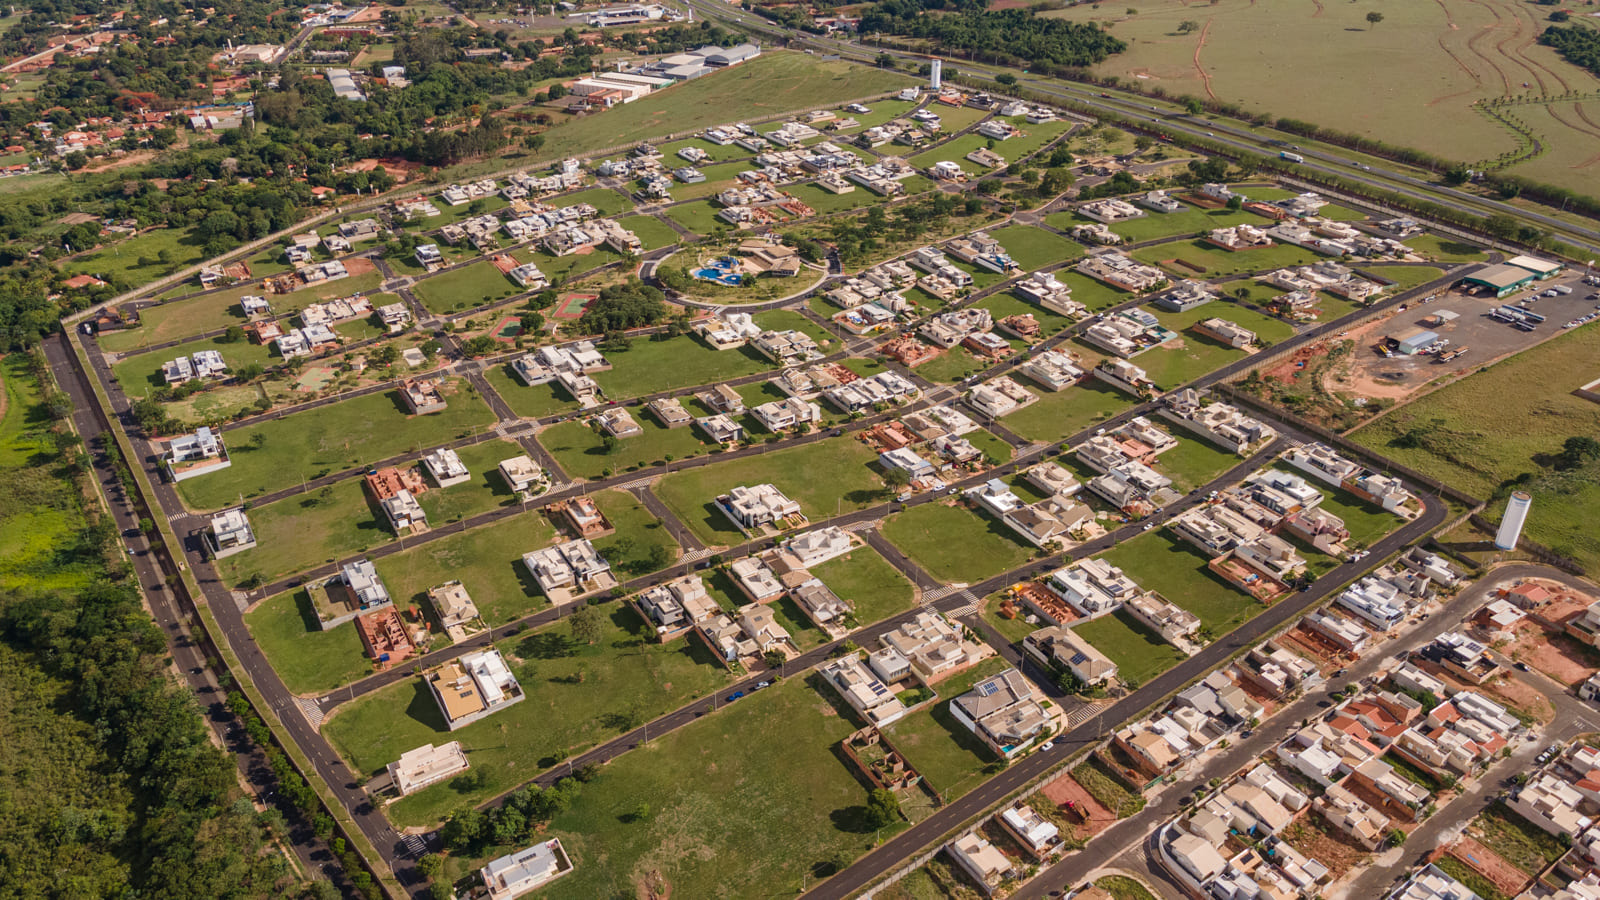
[518,679,894,900]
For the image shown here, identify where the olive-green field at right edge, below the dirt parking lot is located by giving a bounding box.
[1354,327,1600,569]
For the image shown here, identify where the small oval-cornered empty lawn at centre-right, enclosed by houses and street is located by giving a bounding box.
[883,503,1034,583]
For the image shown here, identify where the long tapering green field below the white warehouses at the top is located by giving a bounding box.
[542,50,915,159]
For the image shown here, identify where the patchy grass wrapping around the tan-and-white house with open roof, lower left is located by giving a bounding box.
[323,604,728,826]
